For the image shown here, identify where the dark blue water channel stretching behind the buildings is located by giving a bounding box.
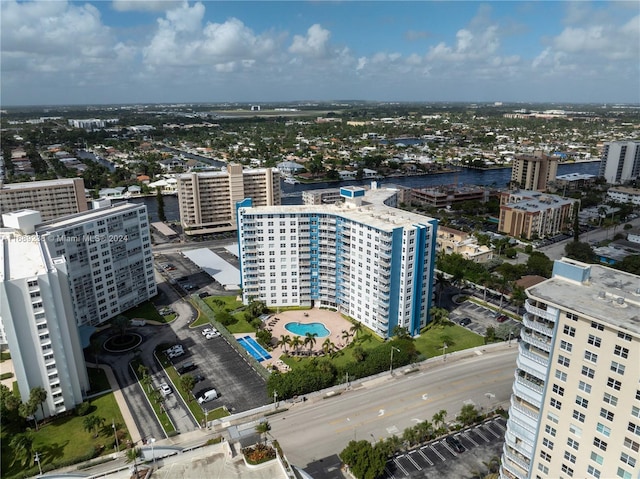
[120,161,600,221]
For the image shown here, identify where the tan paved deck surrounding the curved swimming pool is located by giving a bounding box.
[234,308,353,371]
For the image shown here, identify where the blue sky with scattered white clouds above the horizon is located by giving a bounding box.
[0,0,640,106]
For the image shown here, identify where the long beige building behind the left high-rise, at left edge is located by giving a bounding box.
[0,178,88,227]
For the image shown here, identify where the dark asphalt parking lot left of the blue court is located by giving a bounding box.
[166,326,268,412]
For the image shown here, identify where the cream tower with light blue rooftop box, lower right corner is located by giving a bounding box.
[500,258,640,479]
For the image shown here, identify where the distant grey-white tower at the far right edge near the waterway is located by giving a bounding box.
[598,140,640,185]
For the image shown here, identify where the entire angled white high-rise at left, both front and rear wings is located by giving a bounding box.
[0,204,156,415]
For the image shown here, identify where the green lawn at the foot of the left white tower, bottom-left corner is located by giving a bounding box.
[0,393,128,479]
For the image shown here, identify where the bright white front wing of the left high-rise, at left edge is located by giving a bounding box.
[0,223,89,416]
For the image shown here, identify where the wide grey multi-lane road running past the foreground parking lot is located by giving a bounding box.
[269,344,518,477]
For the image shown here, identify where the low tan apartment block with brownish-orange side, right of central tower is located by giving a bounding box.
[498,190,576,239]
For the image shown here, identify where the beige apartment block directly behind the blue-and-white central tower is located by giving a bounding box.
[178,164,280,235]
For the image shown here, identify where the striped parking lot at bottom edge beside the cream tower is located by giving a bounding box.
[382,417,506,479]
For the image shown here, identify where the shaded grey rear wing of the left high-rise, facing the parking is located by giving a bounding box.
[36,203,157,326]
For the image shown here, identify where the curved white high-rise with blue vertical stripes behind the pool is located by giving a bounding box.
[238,187,437,338]
